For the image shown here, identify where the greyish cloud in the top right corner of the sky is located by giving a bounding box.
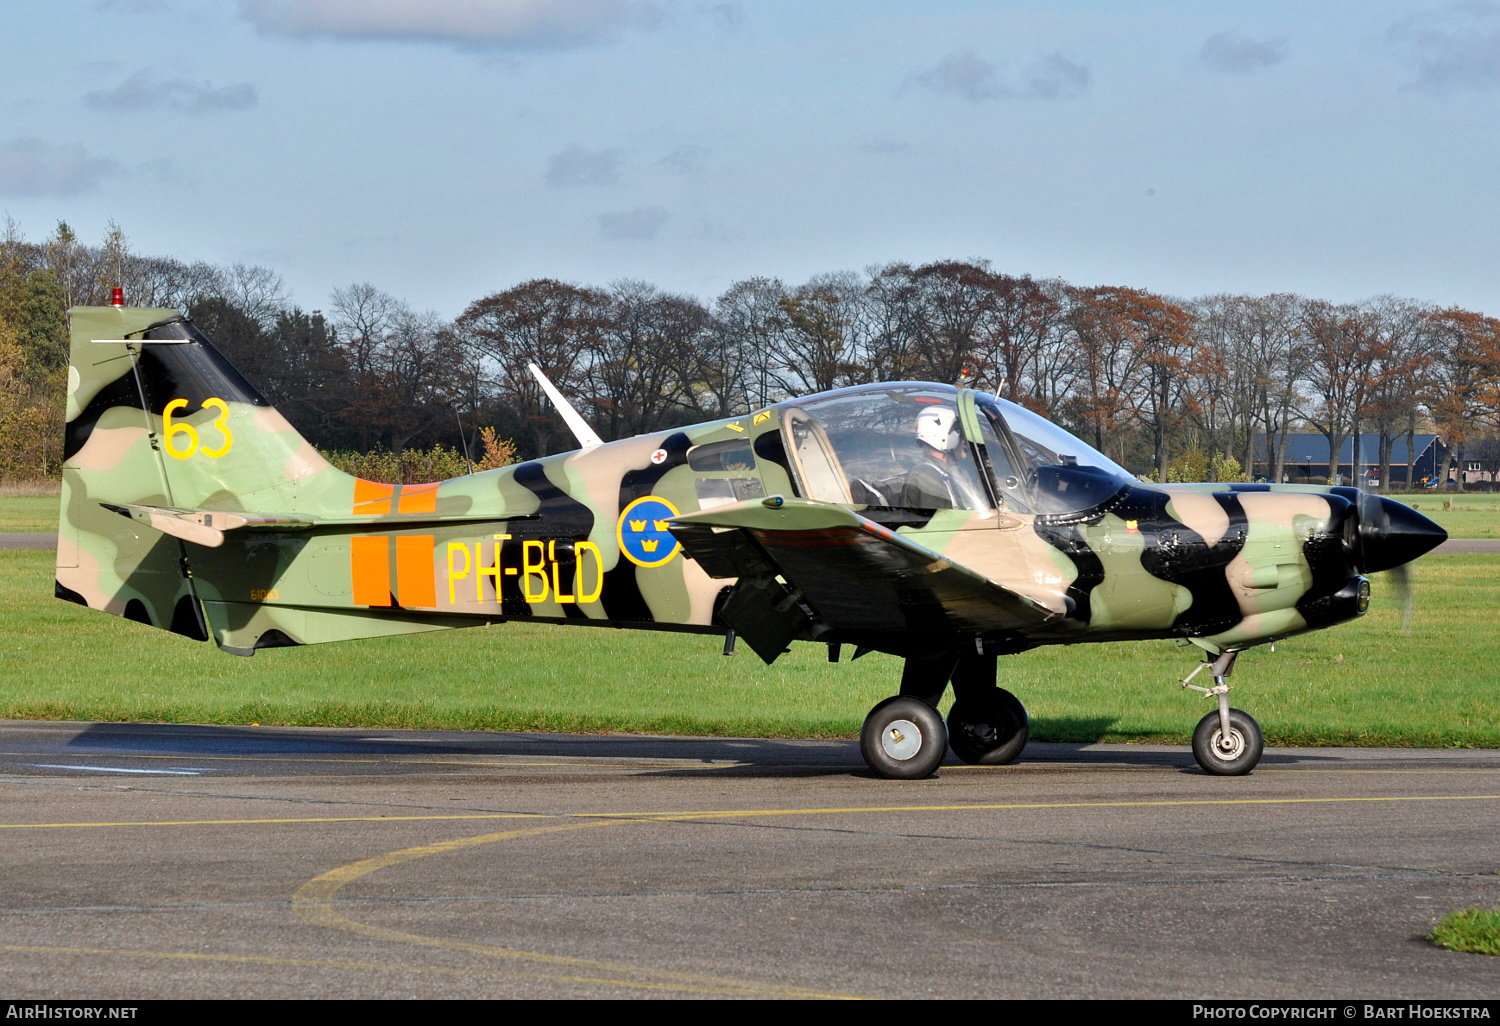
[1388,3,1500,93]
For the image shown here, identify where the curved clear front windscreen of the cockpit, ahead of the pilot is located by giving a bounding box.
[975,395,1136,513]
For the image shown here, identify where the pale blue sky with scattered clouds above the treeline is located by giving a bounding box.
[0,0,1500,317]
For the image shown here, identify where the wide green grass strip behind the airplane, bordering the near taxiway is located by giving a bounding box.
[0,551,1500,747]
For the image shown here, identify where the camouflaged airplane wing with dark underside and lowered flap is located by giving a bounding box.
[671,497,1059,657]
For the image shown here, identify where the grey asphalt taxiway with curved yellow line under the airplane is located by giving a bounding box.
[0,722,1500,999]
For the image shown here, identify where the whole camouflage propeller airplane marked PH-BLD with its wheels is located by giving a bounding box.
[57,306,1446,777]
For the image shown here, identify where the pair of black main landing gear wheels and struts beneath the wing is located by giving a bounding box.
[860,645,1031,780]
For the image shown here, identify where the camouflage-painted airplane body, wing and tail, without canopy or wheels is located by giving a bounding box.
[57,308,1442,672]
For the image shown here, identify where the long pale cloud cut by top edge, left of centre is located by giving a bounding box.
[240,0,662,50]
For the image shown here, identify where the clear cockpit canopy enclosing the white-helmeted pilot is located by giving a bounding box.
[779,383,1133,513]
